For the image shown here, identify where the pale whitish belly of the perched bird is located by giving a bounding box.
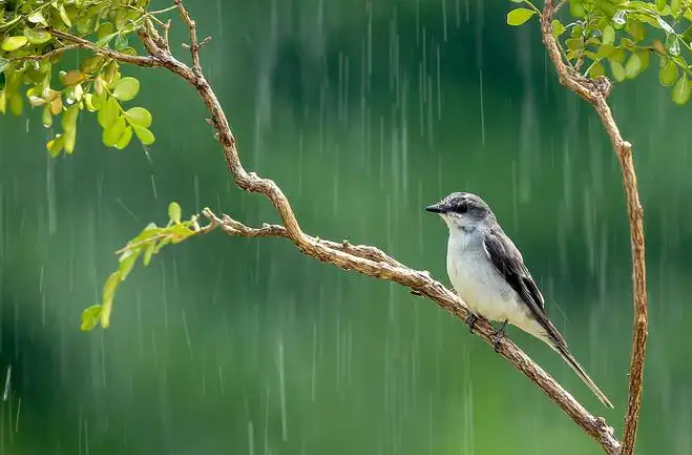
[447,255,524,323]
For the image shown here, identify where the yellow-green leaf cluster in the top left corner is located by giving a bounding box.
[0,0,155,157]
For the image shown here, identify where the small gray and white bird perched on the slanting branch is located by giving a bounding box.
[425,193,613,408]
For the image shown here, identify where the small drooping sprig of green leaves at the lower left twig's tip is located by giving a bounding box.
[81,202,201,331]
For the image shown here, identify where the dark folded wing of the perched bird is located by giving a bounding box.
[483,230,567,348]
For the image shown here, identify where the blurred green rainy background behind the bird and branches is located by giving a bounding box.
[0,0,692,455]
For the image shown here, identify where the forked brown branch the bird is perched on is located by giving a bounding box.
[50,0,620,455]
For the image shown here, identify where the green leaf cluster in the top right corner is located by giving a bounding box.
[507,0,692,105]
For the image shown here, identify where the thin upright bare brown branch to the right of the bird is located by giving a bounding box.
[541,0,649,455]
